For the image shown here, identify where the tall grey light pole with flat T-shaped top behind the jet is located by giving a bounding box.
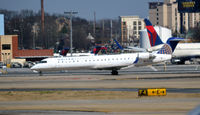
[64,11,78,56]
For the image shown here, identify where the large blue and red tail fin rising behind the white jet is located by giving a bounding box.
[144,19,163,46]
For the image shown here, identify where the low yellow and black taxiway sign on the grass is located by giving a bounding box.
[138,88,167,96]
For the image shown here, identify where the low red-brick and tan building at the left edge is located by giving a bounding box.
[0,35,53,64]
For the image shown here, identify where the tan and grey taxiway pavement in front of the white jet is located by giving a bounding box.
[0,65,200,115]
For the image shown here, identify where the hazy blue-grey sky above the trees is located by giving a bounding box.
[0,0,153,19]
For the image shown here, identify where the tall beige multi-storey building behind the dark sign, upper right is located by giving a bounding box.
[149,0,200,32]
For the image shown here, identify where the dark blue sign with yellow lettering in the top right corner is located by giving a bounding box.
[178,0,200,13]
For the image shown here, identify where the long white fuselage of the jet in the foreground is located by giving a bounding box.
[31,52,171,71]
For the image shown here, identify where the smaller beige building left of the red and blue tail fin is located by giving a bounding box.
[120,16,145,45]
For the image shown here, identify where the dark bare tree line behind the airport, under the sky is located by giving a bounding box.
[0,9,120,52]
